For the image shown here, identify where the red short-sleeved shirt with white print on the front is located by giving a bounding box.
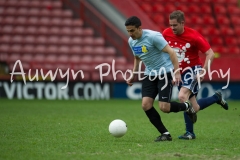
[163,27,210,70]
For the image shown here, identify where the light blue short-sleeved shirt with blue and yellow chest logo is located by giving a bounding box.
[128,29,173,76]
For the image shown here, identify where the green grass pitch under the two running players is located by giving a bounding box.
[0,99,240,160]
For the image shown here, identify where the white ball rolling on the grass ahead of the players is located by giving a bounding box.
[109,119,127,138]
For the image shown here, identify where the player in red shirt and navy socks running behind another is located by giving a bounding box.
[163,10,228,140]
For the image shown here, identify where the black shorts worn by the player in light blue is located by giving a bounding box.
[142,73,173,102]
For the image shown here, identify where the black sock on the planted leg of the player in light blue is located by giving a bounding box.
[145,107,168,134]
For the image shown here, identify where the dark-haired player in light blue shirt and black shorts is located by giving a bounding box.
[125,16,197,142]
